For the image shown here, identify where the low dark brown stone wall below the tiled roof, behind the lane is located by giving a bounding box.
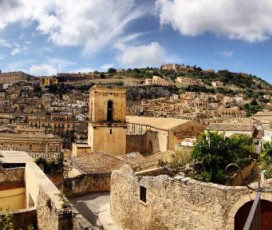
[63,173,111,197]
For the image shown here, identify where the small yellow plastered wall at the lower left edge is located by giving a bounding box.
[0,188,25,211]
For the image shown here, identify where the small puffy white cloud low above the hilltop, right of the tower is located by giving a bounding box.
[118,42,164,67]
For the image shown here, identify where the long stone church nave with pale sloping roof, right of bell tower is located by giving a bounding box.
[127,116,205,153]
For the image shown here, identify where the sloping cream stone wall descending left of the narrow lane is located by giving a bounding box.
[25,162,91,230]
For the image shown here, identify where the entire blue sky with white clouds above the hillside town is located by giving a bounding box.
[0,0,272,83]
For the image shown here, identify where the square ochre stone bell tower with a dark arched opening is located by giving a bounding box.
[88,85,126,155]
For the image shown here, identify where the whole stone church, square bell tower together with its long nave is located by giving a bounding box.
[72,85,204,156]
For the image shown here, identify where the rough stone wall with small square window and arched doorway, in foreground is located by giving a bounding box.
[111,165,272,230]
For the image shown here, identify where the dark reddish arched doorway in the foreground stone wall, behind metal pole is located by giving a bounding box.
[234,200,272,230]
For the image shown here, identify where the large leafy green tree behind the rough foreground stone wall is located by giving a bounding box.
[192,132,253,184]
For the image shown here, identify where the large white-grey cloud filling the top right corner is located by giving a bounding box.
[156,0,272,42]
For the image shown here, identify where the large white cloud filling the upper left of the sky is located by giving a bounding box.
[0,0,147,54]
